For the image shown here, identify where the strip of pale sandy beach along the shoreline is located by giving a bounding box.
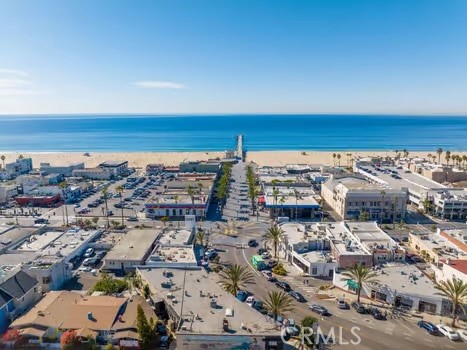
[0,150,467,168]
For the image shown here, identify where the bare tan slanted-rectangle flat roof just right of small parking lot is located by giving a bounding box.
[104,229,161,260]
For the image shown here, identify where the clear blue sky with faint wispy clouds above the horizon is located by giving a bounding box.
[0,0,467,114]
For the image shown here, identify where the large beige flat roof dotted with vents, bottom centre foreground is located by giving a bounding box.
[139,268,279,336]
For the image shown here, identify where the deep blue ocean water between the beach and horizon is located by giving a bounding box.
[0,115,467,152]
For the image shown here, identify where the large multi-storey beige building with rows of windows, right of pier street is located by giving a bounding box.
[321,175,407,222]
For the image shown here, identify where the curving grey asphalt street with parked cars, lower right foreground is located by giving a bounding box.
[215,241,465,350]
